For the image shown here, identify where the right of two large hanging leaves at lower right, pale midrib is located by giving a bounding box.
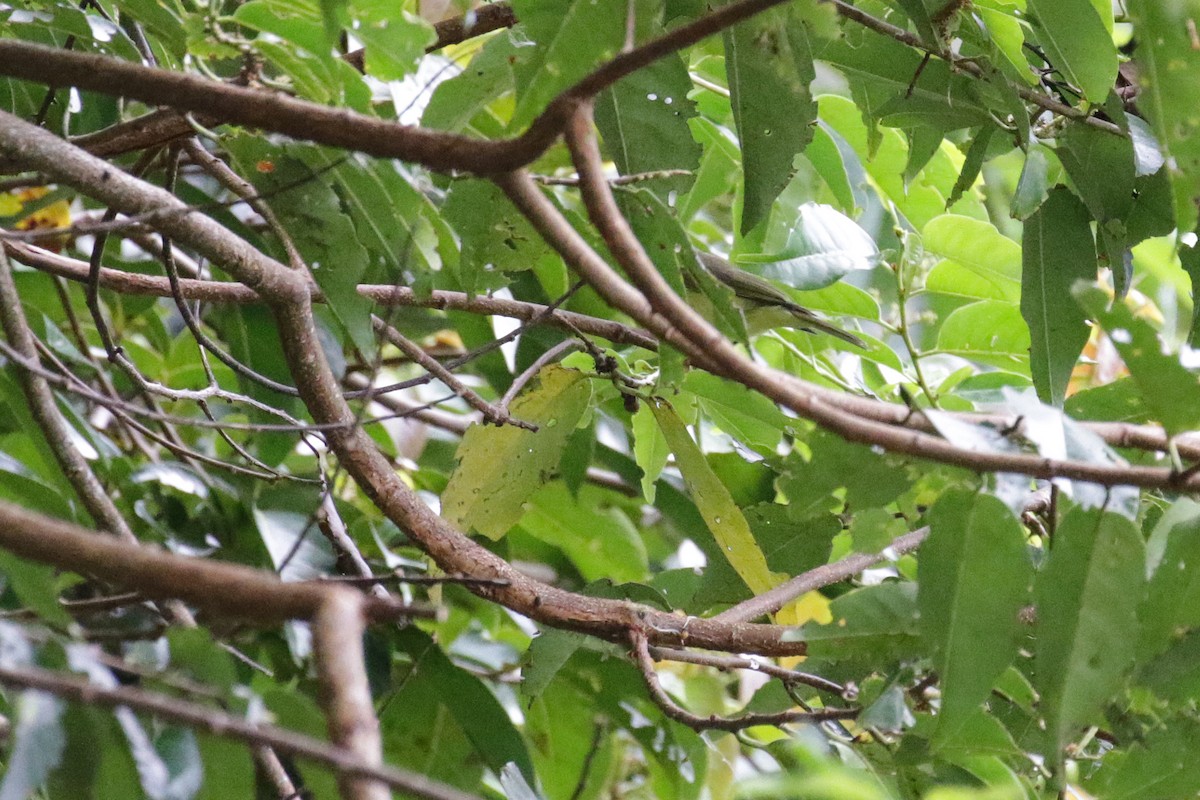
[1036,509,1146,758]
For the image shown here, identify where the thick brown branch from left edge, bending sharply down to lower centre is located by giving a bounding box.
[0,113,806,655]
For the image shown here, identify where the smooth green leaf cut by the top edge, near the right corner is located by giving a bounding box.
[1028,0,1117,106]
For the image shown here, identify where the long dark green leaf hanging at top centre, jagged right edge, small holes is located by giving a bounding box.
[725,12,817,235]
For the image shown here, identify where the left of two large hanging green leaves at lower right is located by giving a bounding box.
[918,492,1033,742]
